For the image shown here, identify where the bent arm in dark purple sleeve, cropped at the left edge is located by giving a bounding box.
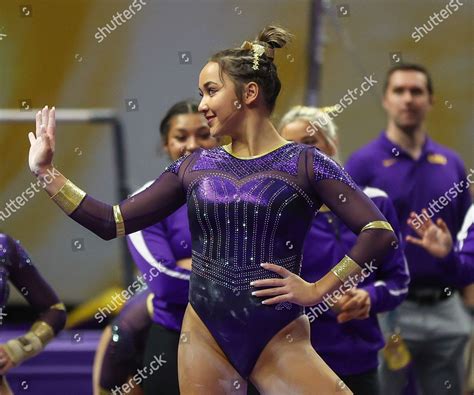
[2,237,66,365]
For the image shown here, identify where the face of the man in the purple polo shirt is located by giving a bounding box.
[383,70,432,130]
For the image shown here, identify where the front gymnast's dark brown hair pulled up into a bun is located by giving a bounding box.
[209,25,292,112]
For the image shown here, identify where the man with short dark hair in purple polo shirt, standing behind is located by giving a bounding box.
[346,65,474,394]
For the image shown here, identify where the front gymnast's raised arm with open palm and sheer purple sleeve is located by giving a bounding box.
[28,107,189,240]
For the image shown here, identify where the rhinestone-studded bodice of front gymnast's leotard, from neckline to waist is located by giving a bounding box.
[174,143,355,296]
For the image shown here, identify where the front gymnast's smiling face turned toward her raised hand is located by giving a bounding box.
[199,62,243,137]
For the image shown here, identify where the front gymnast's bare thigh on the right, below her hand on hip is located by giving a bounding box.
[250,315,352,395]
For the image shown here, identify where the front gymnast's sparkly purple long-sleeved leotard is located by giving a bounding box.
[64,143,396,378]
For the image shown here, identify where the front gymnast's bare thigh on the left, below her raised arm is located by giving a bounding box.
[178,304,247,395]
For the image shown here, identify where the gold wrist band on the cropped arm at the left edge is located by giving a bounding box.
[4,321,54,365]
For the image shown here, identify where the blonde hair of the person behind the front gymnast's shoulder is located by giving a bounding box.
[278,106,339,161]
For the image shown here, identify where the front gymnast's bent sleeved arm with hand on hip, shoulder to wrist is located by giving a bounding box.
[306,149,398,300]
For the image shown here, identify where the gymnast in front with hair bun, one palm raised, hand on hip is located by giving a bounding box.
[25,26,396,395]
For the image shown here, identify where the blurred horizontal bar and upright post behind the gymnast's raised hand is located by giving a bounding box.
[0,108,134,286]
